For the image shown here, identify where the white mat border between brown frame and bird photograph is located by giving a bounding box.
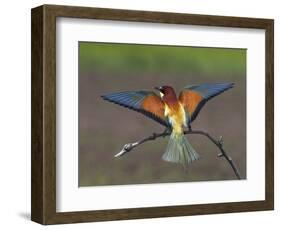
[56,18,265,212]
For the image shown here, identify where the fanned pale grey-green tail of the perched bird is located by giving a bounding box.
[162,132,199,167]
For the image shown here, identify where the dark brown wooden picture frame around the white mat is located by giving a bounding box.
[31,5,274,224]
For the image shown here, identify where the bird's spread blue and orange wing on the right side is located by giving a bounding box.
[179,83,234,122]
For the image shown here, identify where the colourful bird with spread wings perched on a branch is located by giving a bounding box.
[101,83,234,167]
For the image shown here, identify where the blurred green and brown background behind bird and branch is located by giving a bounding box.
[79,42,246,186]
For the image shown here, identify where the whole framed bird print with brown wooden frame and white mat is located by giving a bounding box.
[31,5,274,224]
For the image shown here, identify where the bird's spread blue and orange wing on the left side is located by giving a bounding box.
[101,90,169,126]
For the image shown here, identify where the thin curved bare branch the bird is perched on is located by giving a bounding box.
[114,130,241,180]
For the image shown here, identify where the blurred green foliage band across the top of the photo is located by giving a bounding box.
[79,42,246,75]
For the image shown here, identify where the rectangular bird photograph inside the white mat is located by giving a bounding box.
[78,41,247,187]
